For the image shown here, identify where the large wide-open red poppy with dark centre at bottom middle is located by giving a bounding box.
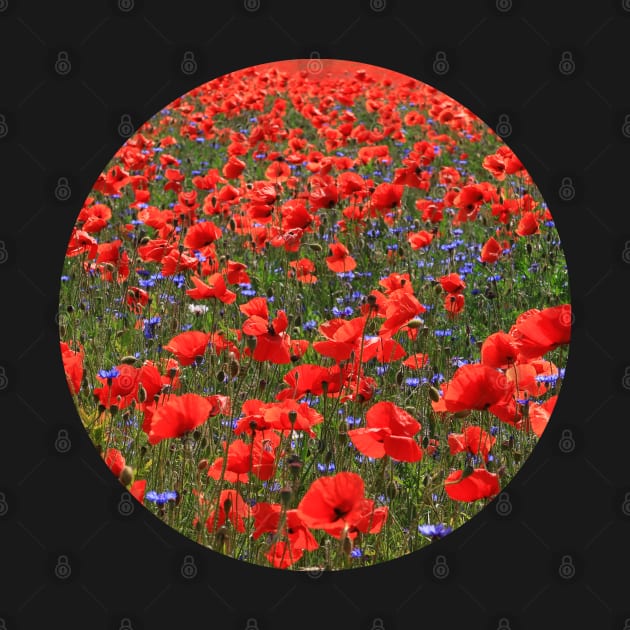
[297,472,384,538]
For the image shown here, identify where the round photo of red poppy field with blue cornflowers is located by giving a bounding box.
[60,59,572,571]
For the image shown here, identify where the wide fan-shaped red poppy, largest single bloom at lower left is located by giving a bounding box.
[143,393,212,444]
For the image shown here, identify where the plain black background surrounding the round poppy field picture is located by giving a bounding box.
[0,0,630,630]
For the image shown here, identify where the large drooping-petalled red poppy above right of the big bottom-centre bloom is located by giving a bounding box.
[348,401,422,462]
